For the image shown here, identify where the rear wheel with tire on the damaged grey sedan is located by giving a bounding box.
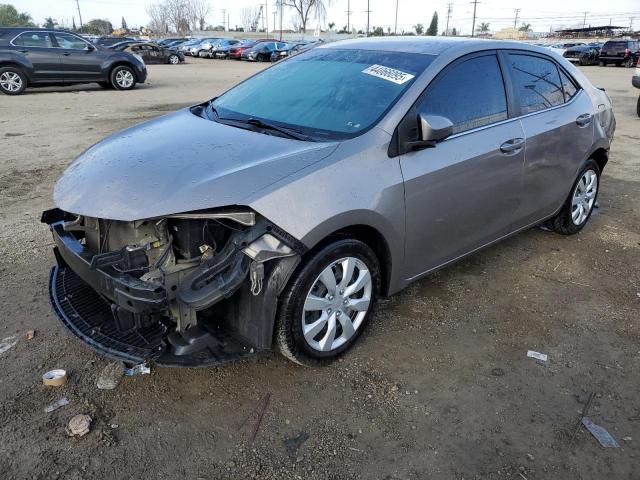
[546,159,600,235]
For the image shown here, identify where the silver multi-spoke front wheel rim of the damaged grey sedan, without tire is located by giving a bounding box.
[302,257,373,352]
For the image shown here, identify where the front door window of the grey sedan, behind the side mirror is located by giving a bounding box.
[418,55,507,133]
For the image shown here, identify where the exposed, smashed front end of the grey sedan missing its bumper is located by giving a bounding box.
[42,209,305,366]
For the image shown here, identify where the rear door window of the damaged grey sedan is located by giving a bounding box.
[509,54,564,114]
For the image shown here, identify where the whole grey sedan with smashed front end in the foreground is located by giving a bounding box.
[42,37,615,366]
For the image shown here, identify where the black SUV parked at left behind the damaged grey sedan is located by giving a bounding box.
[0,27,147,95]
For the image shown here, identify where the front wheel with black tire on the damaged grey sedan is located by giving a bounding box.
[276,238,381,366]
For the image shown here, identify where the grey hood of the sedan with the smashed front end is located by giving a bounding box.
[53,109,337,221]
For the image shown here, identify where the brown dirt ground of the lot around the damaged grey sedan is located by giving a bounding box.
[0,60,640,480]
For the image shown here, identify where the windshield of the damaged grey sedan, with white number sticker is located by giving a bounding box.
[211,48,436,140]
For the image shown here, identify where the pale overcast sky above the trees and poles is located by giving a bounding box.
[8,0,640,34]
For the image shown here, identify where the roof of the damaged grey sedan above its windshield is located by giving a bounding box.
[318,36,540,55]
